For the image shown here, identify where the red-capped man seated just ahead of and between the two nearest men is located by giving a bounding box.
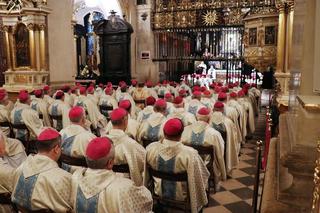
[60,106,96,172]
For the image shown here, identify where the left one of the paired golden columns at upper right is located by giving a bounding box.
[276,5,287,72]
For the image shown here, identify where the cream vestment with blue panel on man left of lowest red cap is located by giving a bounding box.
[12,154,72,213]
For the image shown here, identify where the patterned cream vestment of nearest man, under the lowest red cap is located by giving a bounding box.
[71,169,152,213]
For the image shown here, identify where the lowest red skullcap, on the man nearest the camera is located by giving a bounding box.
[86,137,112,160]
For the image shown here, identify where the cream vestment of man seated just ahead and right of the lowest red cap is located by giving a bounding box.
[107,129,146,186]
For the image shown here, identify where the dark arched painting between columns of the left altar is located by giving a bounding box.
[15,24,31,67]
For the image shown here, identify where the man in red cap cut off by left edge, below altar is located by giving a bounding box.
[0,90,11,136]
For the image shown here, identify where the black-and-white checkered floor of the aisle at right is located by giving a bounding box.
[204,110,266,213]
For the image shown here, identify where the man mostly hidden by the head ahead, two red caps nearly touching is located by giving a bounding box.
[105,100,139,140]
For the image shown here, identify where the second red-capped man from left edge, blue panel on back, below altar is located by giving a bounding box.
[10,91,43,141]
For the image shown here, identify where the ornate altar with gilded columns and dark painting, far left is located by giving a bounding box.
[0,0,50,92]
